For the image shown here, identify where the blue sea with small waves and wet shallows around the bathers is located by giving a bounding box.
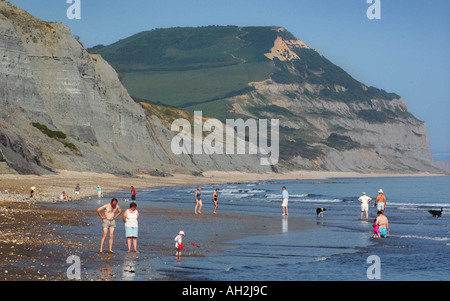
[53,176,450,281]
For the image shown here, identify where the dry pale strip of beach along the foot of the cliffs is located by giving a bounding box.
[0,170,445,202]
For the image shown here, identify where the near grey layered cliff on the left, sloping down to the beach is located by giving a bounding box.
[0,1,270,174]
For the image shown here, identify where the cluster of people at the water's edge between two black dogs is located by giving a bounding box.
[358,189,389,238]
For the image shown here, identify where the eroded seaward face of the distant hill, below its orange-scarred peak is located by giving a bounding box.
[228,27,438,172]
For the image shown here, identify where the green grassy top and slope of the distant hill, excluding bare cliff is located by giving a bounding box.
[90,26,276,114]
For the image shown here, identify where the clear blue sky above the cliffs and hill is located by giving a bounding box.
[9,0,450,160]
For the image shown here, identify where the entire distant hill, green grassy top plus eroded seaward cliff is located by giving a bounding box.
[91,25,437,173]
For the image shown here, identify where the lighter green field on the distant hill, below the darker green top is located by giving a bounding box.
[122,63,273,113]
